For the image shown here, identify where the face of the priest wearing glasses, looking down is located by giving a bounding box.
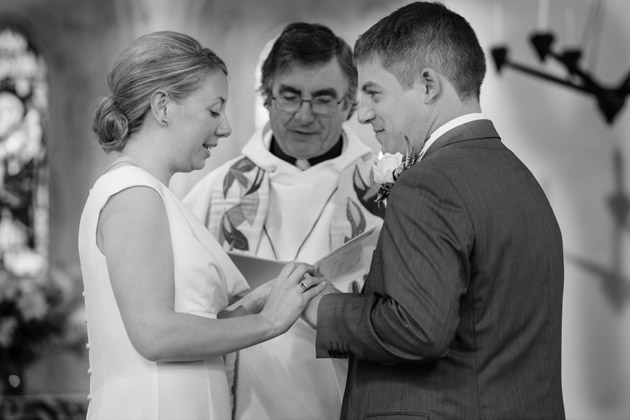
[268,58,351,159]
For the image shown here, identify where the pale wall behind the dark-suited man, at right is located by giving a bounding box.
[454,0,630,420]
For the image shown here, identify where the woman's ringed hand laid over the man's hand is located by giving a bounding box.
[261,262,327,332]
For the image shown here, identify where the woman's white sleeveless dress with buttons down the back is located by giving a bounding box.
[79,166,248,420]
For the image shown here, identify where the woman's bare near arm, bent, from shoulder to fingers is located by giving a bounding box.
[97,187,323,361]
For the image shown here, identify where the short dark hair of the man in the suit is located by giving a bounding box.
[354,2,486,100]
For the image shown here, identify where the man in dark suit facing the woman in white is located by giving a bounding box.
[304,2,565,420]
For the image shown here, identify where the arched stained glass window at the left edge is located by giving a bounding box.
[0,25,48,288]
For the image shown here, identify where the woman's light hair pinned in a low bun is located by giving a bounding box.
[92,31,228,152]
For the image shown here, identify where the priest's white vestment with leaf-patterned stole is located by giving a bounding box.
[184,122,382,420]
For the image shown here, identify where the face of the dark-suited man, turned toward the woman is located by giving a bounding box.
[357,58,428,153]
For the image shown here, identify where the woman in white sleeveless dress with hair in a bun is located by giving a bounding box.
[79,32,325,420]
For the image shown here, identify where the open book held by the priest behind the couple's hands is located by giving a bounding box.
[228,227,380,289]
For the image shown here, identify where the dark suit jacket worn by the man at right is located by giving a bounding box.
[316,120,564,420]
